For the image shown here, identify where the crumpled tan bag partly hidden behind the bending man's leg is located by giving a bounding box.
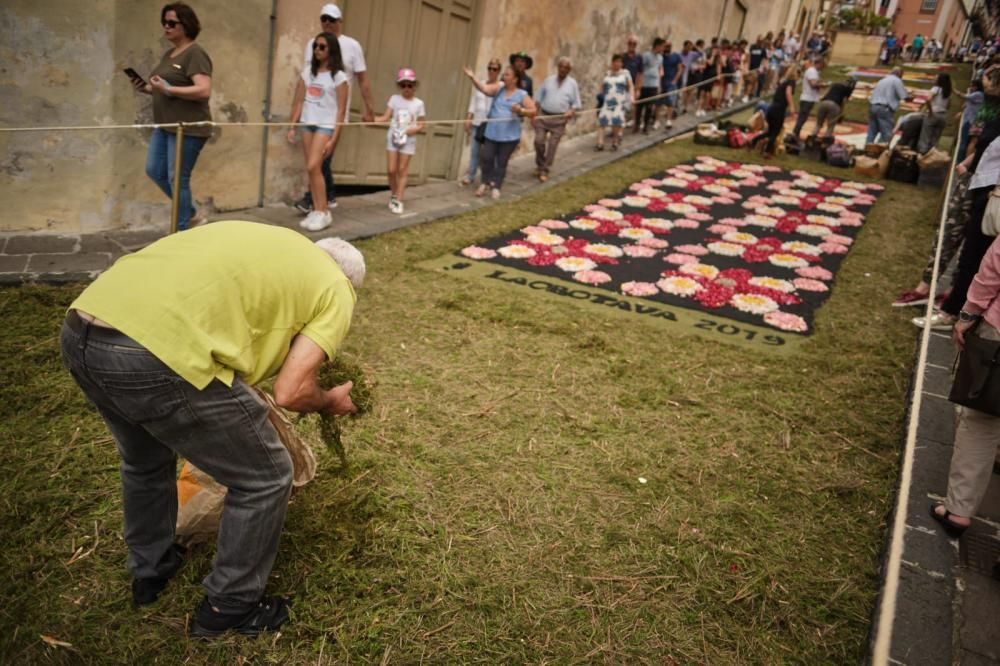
[175,387,316,548]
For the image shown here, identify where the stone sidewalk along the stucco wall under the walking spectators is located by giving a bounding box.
[0,101,755,285]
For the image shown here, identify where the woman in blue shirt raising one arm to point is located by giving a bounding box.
[463,66,537,199]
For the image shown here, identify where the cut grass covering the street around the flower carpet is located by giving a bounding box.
[0,134,942,664]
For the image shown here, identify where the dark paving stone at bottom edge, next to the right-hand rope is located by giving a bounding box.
[889,566,952,666]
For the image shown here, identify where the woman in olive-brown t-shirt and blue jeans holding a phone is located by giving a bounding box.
[132,2,212,230]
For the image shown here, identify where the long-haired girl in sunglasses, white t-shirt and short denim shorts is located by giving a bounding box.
[287,32,347,231]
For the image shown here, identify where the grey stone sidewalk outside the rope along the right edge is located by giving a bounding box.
[890,328,1000,666]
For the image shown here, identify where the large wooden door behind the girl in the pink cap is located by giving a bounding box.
[333,0,479,185]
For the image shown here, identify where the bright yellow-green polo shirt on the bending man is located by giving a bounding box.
[70,221,357,390]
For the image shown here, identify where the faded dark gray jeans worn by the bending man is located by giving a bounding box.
[60,311,292,612]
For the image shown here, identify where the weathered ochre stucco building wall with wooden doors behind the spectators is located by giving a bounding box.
[0,0,796,232]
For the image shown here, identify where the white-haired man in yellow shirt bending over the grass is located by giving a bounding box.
[61,221,365,636]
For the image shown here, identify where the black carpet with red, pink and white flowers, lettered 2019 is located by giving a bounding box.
[422,156,883,350]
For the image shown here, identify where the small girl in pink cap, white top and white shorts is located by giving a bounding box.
[375,68,427,215]
